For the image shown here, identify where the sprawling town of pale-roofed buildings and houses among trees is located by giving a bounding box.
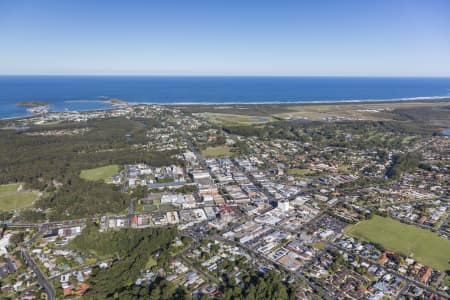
[0,104,450,299]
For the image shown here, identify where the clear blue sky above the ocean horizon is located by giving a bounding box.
[0,0,450,76]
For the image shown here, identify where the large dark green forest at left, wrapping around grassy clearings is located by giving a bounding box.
[0,118,177,220]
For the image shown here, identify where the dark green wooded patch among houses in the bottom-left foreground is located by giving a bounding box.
[69,225,180,299]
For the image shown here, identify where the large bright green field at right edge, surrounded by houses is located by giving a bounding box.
[345,215,450,271]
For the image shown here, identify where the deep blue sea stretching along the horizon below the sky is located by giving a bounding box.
[0,76,450,118]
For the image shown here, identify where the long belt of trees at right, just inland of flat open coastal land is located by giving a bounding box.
[223,121,438,149]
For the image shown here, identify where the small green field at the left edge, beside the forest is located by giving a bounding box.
[0,183,38,211]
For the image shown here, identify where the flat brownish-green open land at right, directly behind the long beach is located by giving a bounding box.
[176,98,450,129]
